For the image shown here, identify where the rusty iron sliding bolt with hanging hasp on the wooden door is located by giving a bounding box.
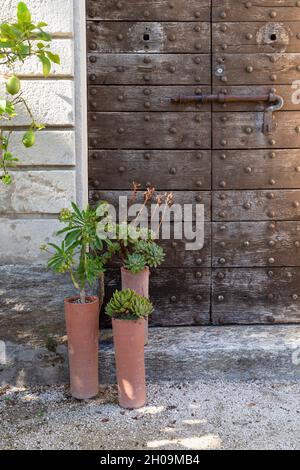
[171,93,284,135]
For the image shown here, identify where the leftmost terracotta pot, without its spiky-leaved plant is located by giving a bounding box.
[65,297,99,399]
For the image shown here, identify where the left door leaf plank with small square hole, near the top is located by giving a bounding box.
[87,21,210,54]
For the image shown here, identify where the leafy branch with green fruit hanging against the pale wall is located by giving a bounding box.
[0,2,60,185]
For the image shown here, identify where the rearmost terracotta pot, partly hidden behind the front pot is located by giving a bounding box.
[121,267,150,345]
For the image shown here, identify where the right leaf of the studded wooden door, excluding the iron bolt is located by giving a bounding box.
[212,0,300,324]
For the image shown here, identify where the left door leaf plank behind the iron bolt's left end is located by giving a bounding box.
[88,85,211,112]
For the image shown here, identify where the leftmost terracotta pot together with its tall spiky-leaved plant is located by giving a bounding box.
[42,202,110,399]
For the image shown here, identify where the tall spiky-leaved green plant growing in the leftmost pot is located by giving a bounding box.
[41,202,113,303]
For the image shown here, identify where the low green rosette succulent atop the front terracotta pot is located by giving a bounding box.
[105,289,153,320]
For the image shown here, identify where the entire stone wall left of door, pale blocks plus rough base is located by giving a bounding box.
[0,0,88,372]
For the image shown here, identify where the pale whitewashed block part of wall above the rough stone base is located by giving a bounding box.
[0,0,87,266]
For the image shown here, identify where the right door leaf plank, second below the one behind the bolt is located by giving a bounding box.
[212,149,300,189]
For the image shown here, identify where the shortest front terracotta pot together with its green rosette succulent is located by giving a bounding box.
[106,289,153,409]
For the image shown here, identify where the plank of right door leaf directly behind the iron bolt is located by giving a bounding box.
[212,83,300,111]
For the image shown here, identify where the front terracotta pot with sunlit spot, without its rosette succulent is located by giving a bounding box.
[113,319,146,409]
